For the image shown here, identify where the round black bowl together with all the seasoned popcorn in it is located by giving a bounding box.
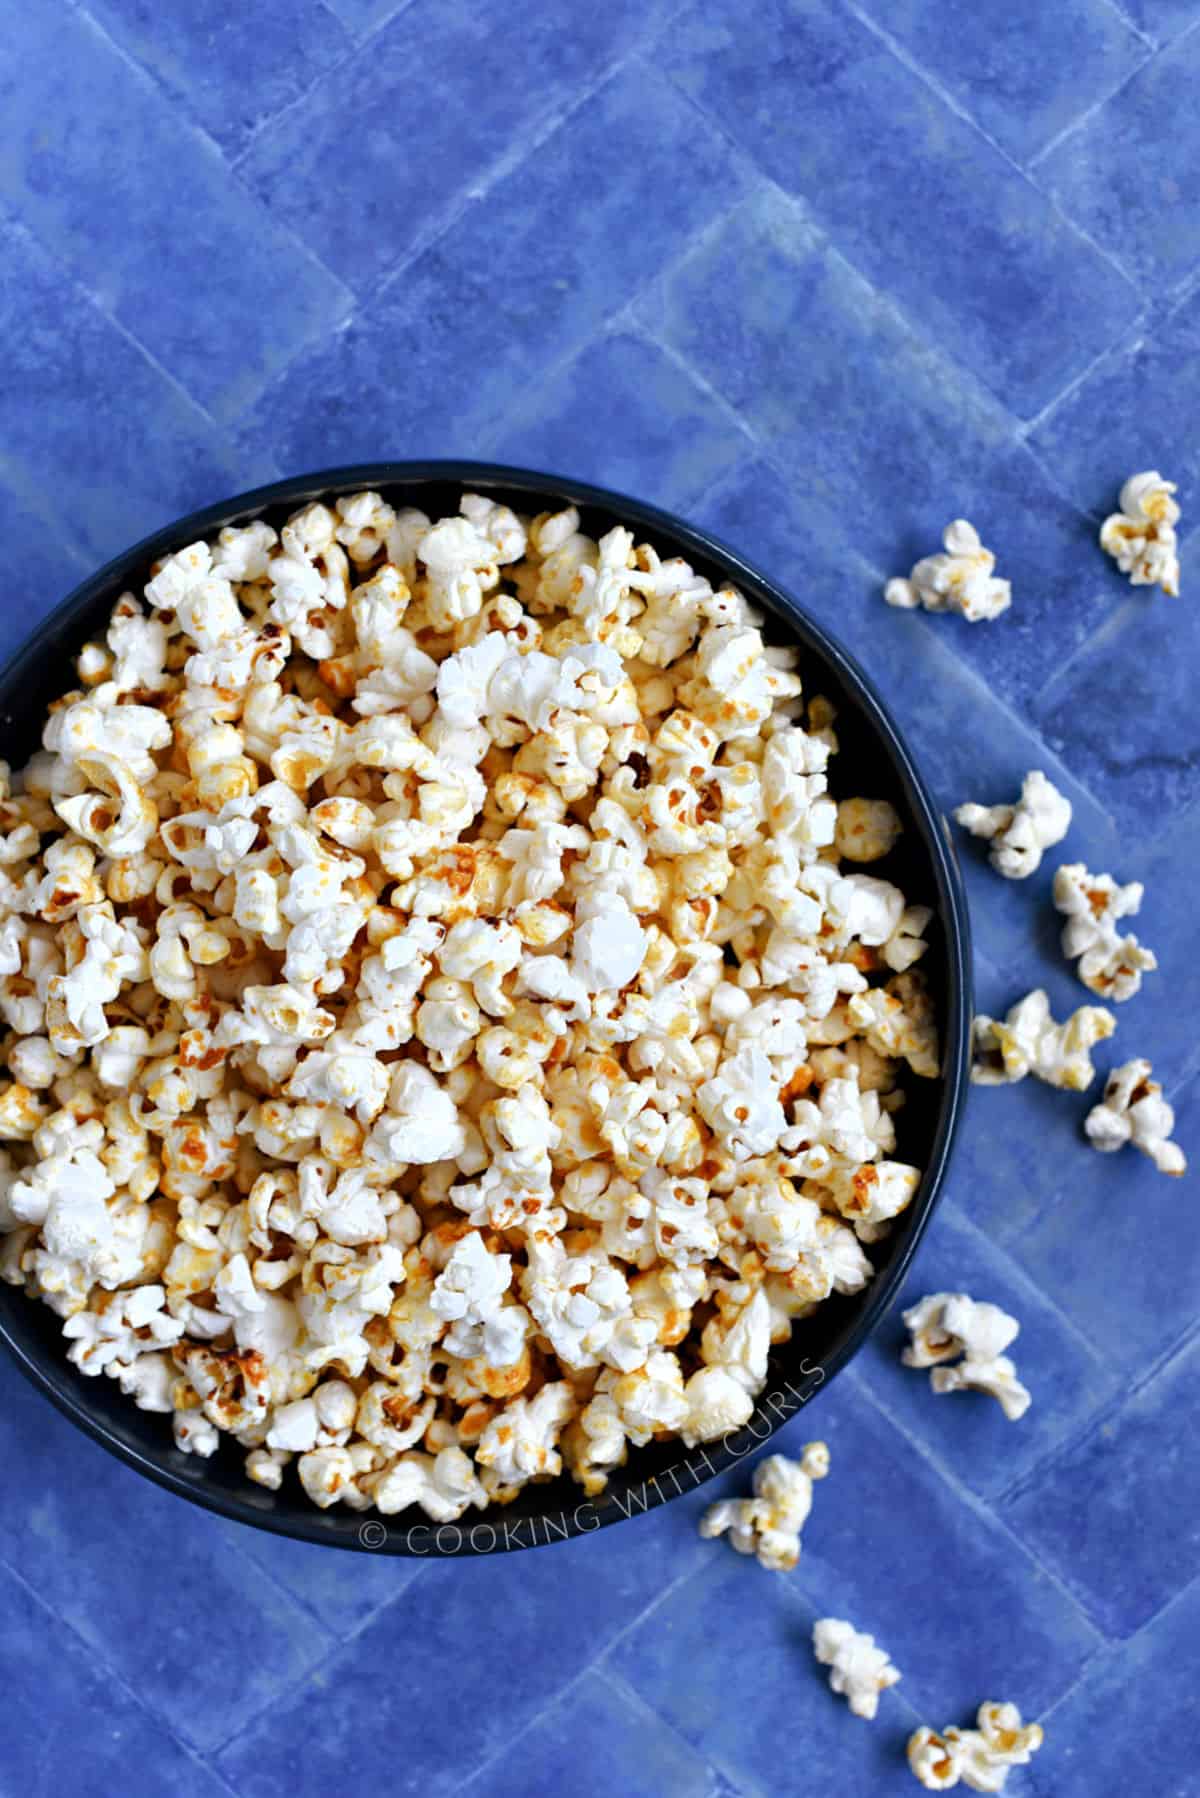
[0,462,970,1553]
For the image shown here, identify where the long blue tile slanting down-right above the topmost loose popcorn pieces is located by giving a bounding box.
[667,0,1137,415]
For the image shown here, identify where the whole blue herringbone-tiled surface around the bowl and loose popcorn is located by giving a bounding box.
[0,0,1200,1798]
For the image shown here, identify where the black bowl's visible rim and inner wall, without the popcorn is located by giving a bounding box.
[0,462,972,1555]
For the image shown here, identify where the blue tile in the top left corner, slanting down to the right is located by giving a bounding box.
[0,0,345,415]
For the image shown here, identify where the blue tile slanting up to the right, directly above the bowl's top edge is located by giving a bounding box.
[245,61,743,467]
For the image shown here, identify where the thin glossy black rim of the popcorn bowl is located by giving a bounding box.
[0,458,973,1557]
